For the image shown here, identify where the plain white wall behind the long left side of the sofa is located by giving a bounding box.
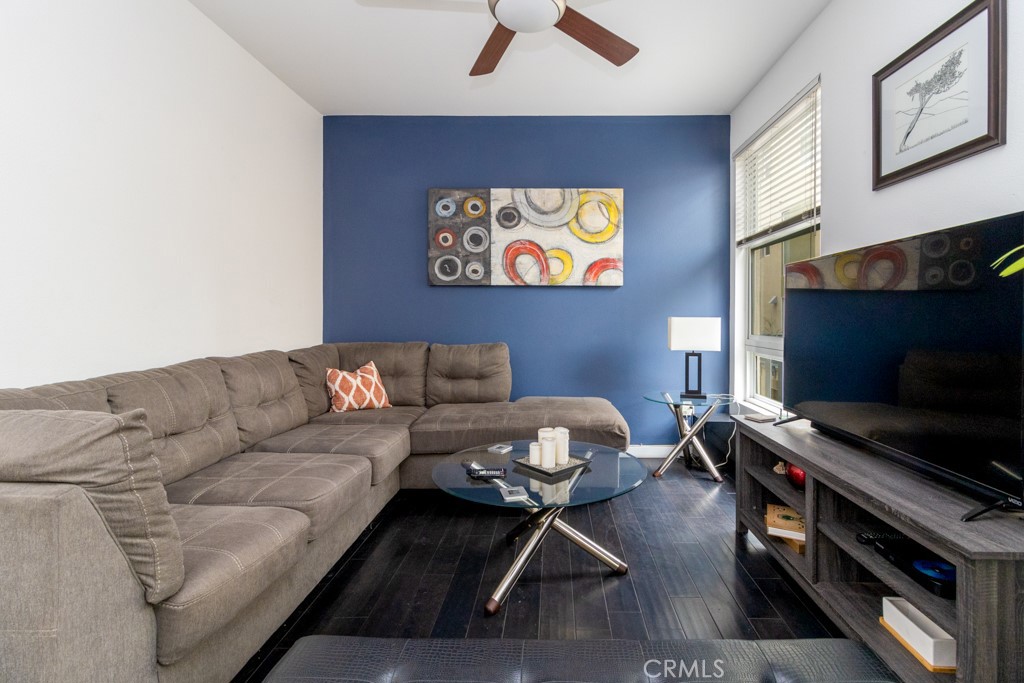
[0,0,323,386]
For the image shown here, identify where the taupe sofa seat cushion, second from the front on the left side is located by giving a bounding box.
[167,453,370,541]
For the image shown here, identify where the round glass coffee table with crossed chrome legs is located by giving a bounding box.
[433,441,647,614]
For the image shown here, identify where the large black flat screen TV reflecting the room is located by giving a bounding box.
[782,213,1024,518]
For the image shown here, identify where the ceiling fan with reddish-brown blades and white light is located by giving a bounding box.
[469,0,640,76]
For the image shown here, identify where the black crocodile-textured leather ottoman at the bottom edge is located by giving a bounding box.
[266,636,899,683]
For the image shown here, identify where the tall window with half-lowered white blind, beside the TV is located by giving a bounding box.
[733,81,821,410]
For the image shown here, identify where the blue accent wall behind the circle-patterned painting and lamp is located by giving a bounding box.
[324,116,730,443]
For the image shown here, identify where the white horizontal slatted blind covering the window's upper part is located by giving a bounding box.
[733,82,821,245]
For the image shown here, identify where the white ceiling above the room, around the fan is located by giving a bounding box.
[190,0,829,116]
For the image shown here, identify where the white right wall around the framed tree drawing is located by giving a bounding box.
[732,0,1024,253]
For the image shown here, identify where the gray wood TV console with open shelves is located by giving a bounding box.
[736,418,1024,683]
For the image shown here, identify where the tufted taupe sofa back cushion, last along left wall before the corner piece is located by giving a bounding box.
[214,351,307,451]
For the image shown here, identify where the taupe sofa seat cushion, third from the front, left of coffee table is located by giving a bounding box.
[252,424,409,485]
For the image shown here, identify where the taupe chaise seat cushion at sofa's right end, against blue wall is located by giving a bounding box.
[409,397,629,455]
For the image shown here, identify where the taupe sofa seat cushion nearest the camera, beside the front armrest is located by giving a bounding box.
[156,505,309,666]
